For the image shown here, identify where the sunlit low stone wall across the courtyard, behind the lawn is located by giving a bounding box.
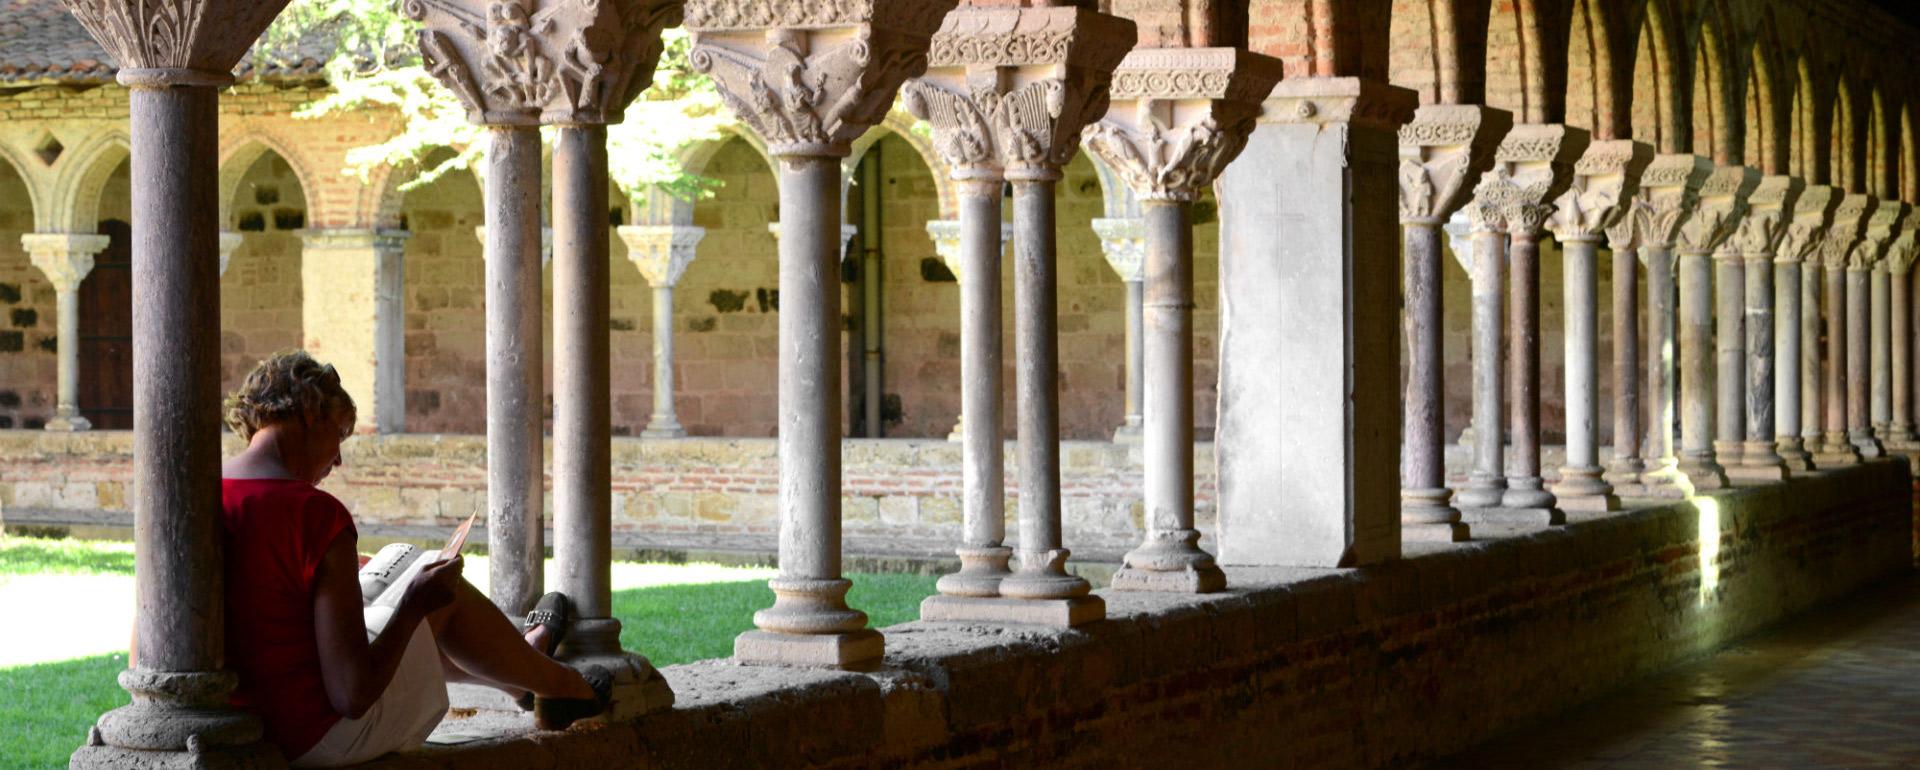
[0,430,1213,559]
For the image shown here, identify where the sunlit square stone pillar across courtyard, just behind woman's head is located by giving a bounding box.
[300,229,411,434]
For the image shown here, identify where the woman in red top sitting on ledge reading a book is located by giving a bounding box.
[221,351,611,766]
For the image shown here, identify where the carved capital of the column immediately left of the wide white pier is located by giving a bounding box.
[1085,48,1281,200]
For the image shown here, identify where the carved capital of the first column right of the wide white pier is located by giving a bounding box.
[1400,104,1513,225]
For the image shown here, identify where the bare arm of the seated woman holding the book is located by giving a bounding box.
[313,532,461,718]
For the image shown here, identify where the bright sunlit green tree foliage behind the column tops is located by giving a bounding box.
[253,0,733,202]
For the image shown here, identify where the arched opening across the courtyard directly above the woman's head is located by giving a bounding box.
[221,146,307,390]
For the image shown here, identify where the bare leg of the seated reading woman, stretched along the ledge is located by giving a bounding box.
[428,580,593,697]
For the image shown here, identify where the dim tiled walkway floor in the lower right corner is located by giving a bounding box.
[1438,576,1920,770]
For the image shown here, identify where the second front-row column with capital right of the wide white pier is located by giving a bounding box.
[1469,123,1588,524]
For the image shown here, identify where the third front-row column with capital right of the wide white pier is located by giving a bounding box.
[1548,140,1653,511]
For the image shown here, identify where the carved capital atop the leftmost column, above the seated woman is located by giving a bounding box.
[65,0,288,79]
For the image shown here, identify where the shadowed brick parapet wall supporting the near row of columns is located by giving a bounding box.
[382,463,1910,768]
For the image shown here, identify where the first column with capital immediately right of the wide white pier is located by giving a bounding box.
[1398,104,1513,541]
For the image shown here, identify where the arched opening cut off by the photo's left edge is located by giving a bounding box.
[0,149,43,430]
